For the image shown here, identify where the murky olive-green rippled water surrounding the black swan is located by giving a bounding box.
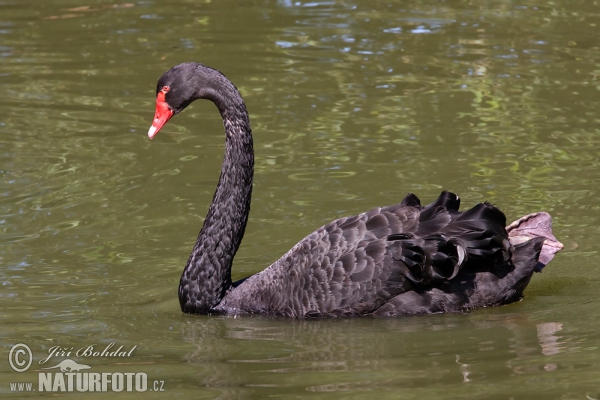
[0,0,600,399]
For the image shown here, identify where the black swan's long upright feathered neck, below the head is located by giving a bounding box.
[179,90,254,314]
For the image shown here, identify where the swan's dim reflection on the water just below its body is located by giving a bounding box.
[176,314,576,397]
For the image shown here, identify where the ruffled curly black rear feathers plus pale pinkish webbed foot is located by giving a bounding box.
[388,191,563,284]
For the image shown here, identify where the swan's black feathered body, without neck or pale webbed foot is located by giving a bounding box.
[215,192,543,317]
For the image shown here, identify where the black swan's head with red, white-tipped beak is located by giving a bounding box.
[148,62,241,139]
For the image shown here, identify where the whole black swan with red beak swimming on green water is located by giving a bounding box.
[148,62,563,318]
